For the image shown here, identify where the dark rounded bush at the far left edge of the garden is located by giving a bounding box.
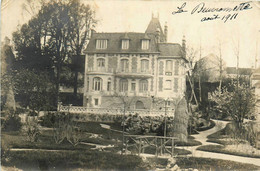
[3,114,22,131]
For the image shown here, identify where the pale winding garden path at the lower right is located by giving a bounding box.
[176,120,260,166]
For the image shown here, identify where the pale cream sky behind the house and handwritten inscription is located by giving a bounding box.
[1,0,260,67]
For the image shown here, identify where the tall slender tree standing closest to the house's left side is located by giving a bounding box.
[69,0,96,98]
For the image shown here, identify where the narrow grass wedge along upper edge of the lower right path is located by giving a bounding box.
[197,145,260,158]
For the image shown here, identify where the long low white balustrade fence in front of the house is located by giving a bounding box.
[58,105,174,116]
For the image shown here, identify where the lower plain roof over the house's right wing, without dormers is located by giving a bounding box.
[158,43,183,57]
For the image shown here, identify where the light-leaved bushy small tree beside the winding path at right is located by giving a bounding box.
[210,82,255,128]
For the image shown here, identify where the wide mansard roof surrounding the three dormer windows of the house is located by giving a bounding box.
[86,32,158,53]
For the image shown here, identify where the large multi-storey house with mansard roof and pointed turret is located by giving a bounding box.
[83,17,186,110]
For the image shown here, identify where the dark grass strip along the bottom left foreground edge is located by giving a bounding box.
[2,150,148,170]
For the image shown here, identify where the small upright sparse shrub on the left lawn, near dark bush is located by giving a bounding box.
[25,117,40,143]
